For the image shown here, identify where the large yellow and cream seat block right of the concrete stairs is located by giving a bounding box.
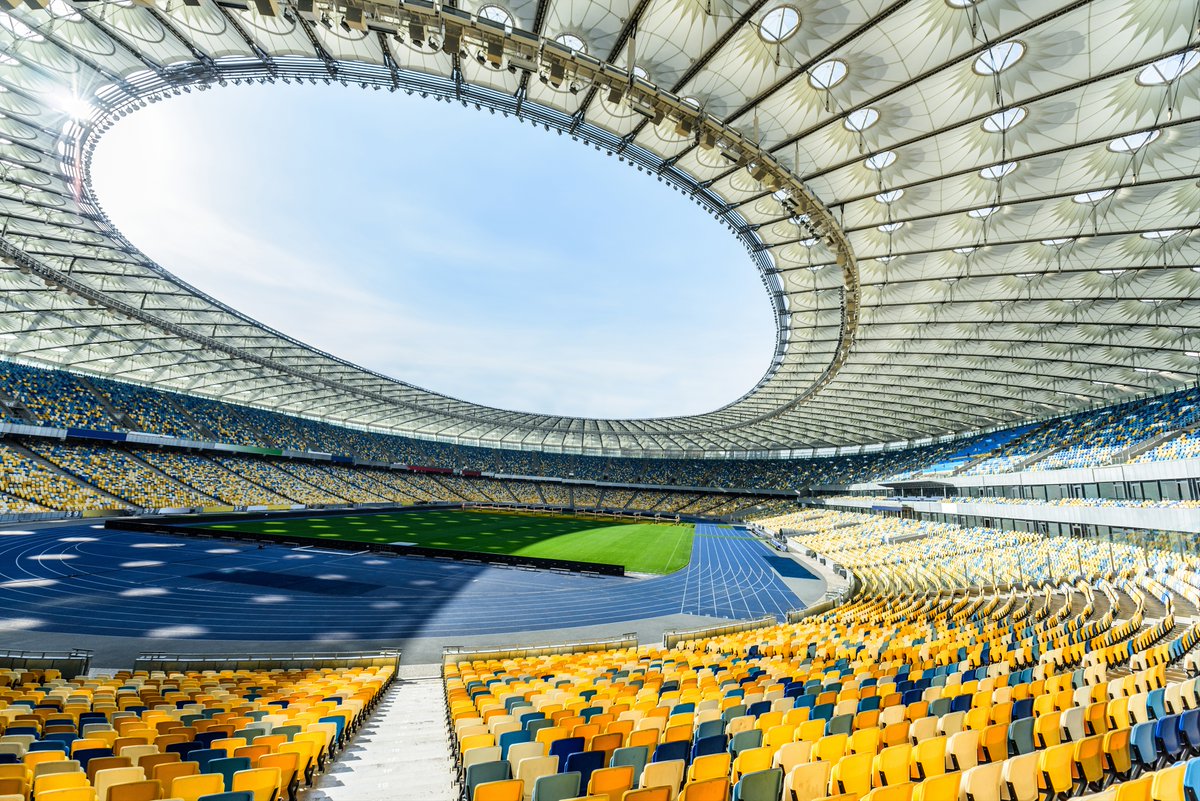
[444,513,1200,801]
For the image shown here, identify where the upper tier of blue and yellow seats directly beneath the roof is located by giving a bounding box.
[0,361,1200,494]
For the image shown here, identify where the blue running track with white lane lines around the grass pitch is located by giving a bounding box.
[0,523,803,642]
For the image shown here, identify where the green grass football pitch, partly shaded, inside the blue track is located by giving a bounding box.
[197,510,695,573]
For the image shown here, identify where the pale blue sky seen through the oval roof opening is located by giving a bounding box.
[94,86,774,417]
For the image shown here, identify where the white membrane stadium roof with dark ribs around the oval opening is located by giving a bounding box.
[0,0,1200,454]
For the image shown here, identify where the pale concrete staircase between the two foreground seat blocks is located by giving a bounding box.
[300,666,460,801]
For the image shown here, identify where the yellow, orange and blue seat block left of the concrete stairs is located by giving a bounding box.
[0,668,394,801]
